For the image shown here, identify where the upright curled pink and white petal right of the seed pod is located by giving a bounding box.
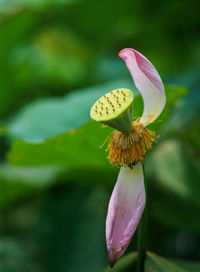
[119,48,166,126]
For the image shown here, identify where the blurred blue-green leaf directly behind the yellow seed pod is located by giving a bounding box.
[7,79,134,142]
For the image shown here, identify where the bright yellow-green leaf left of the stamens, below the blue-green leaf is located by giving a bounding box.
[8,121,111,169]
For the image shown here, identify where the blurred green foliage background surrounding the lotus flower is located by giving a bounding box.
[0,0,200,272]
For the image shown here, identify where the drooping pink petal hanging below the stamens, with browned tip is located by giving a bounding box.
[106,163,145,267]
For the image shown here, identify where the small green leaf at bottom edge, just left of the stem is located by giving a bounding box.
[101,252,137,272]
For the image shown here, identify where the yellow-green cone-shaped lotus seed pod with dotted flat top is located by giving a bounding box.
[90,88,133,134]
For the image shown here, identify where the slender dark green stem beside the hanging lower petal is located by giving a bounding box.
[137,165,147,272]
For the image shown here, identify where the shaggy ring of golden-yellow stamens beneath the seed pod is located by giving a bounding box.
[108,121,157,167]
